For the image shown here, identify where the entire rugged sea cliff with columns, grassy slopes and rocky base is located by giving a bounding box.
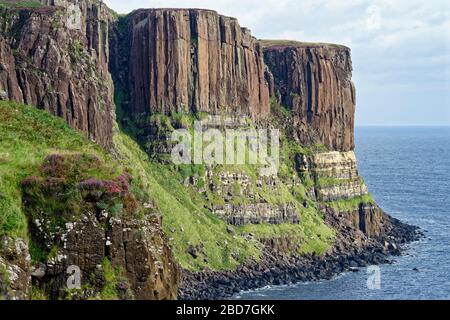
[0,0,419,299]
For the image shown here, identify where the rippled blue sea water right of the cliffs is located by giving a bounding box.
[235,127,450,300]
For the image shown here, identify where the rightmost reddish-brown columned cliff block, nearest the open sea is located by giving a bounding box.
[263,41,355,151]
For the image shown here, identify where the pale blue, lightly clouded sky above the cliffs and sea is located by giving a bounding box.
[104,0,450,126]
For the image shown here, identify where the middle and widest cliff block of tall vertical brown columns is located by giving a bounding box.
[111,9,269,118]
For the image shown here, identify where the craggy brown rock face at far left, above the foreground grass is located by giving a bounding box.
[0,0,115,146]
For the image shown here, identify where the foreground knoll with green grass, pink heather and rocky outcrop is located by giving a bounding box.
[0,101,178,299]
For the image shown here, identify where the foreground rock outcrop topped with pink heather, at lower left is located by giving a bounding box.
[22,155,179,299]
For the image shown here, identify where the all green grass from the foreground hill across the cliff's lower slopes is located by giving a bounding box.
[0,101,333,270]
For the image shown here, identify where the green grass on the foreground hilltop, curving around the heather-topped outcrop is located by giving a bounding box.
[0,101,118,239]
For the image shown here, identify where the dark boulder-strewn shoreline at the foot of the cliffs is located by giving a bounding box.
[178,215,424,300]
